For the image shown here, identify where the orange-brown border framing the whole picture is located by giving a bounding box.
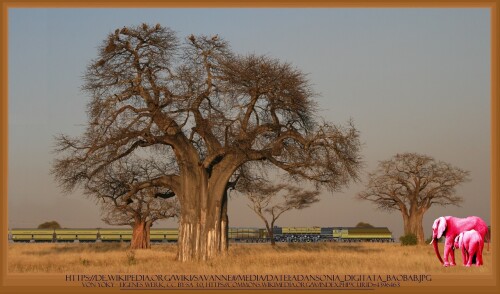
[0,0,500,293]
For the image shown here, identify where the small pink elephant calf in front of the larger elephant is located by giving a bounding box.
[454,230,484,266]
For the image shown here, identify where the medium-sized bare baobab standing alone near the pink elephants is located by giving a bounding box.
[358,153,469,244]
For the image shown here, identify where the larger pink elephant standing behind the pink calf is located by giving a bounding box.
[431,216,488,266]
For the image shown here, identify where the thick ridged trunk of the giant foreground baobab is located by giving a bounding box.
[177,156,238,261]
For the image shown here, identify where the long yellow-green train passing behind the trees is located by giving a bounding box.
[5,227,394,243]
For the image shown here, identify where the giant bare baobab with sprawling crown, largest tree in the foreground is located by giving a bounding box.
[54,24,360,261]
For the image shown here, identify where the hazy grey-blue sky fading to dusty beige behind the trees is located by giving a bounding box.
[8,9,491,237]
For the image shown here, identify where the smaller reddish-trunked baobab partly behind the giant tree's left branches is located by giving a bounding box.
[84,157,180,249]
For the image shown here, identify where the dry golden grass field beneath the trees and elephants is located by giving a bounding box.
[7,243,493,275]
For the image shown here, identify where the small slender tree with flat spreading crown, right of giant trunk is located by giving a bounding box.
[238,181,319,246]
